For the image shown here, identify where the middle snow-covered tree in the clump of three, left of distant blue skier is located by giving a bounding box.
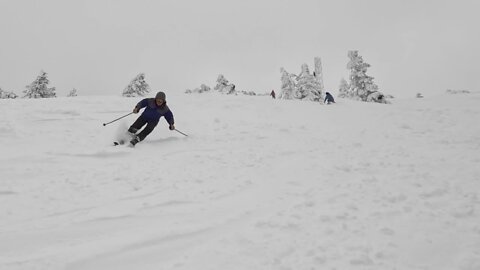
[296,64,323,101]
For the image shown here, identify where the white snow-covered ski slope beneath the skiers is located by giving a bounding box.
[0,93,480,270]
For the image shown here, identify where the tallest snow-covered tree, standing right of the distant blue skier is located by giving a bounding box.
[347,51,378,101]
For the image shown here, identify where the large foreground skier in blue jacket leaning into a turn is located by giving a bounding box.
[128,92,175,146]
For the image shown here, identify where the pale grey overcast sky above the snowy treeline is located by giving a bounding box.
[0,0,480,96]
